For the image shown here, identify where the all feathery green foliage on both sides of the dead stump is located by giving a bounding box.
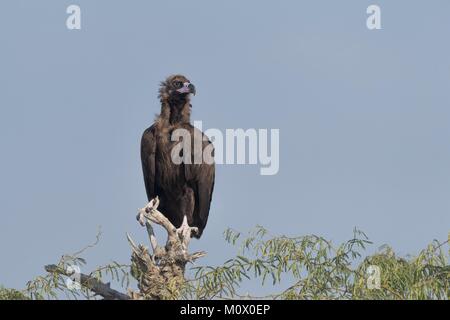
[0,226,450,300]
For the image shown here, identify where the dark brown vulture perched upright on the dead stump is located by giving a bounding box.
[141,75,215,238]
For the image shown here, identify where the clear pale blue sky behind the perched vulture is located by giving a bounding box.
[0,0,450,296]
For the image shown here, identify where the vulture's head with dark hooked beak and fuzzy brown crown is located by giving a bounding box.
[159,74,195,105]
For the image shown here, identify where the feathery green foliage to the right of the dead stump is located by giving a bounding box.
[184,227,450,299]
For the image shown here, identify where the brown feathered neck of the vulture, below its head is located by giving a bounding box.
[159,97,191,125]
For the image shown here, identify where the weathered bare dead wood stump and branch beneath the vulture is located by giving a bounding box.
[41,198,206,300]
